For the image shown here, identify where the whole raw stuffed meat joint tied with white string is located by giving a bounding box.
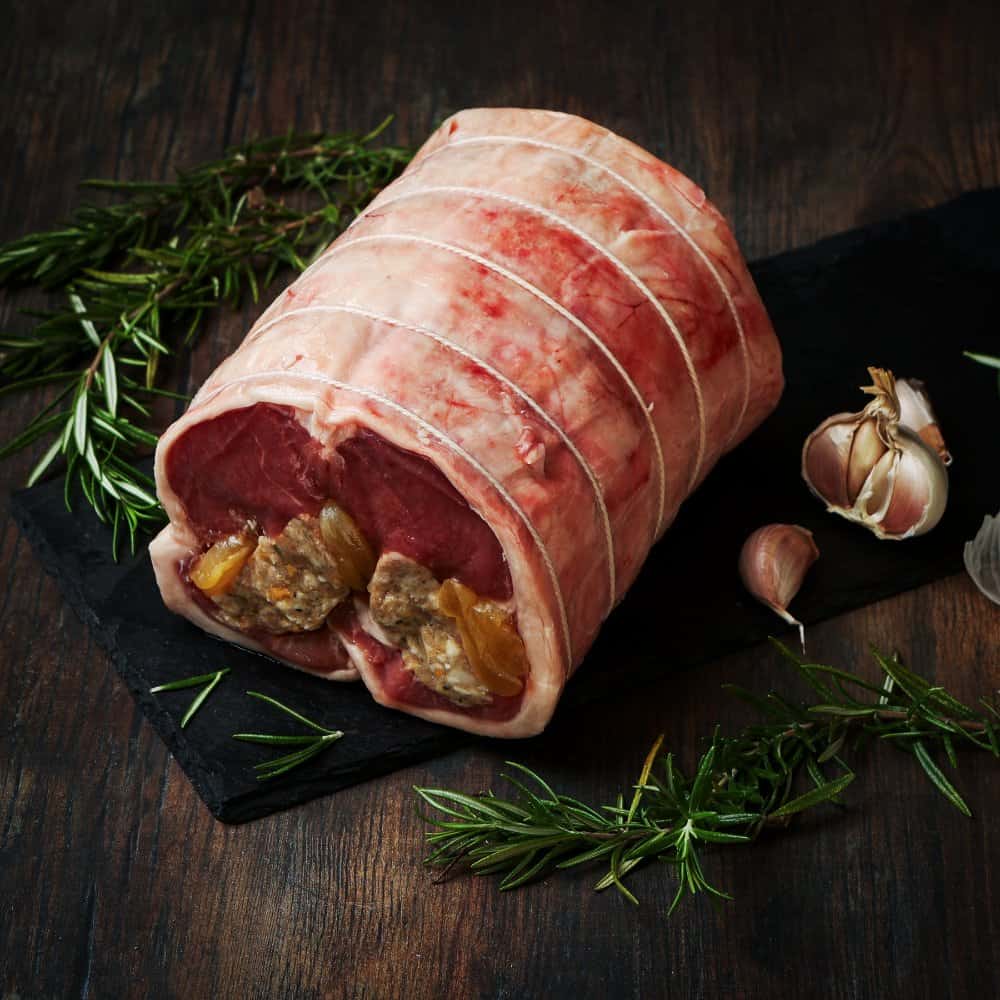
[151,109,782,737]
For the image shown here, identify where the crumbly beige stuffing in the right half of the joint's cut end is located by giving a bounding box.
[368,552,492,705]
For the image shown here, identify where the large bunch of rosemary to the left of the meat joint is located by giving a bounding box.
[0,119,412,552]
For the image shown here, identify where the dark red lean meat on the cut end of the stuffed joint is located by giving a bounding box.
[167,403,520,696]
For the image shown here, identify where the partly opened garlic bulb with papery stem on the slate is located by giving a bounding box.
[802,368,948,540]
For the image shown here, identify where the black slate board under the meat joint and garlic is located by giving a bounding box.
[12,190,1000,823]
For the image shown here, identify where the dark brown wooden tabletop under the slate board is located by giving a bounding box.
[0,0,1000,998]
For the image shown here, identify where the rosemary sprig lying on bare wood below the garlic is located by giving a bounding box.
[415,642,1000,913]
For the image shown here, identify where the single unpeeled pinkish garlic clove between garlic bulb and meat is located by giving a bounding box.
[739,524,819,652]
